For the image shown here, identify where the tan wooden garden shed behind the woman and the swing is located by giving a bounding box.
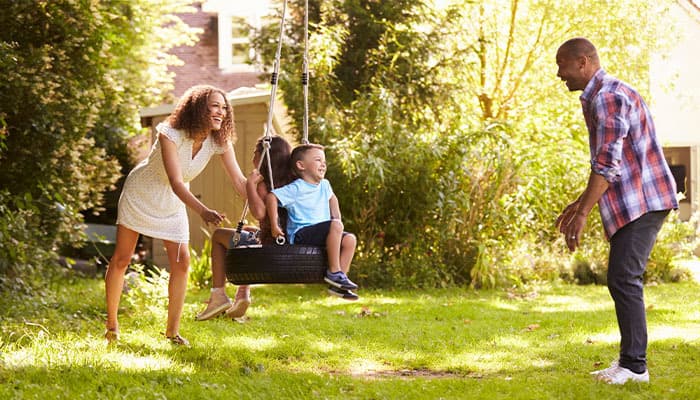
[140,88,291,266]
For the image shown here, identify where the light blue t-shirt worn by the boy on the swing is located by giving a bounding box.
[272,179,333,244]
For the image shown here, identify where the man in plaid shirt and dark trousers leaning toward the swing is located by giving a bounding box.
[556,38,678,384]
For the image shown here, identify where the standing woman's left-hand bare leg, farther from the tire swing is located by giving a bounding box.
[105,225,139,332]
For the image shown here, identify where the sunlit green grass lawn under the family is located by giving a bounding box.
[0,277,700,400]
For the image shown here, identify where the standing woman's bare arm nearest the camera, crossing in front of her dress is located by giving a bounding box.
[158,133,224,225]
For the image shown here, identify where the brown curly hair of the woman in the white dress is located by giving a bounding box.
[168,85,236,146]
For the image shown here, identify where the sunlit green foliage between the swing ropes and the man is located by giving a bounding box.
[256,0,675,287]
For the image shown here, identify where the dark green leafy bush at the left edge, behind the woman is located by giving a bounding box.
[0,0,198,288]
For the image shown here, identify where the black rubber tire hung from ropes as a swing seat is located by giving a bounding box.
[225,244,328,285]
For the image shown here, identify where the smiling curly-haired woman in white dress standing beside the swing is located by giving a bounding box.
[105,85,246,346]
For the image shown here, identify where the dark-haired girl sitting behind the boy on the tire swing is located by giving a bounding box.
[195,136,293,321]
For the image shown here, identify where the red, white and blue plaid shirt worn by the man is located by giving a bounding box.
[581,69,678,239]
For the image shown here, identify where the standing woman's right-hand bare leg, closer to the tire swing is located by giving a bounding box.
[164,241,190,338]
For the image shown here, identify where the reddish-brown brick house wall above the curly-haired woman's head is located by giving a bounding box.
[169,2,261,98]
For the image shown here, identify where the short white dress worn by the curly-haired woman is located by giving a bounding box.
[117,122,230,243]
